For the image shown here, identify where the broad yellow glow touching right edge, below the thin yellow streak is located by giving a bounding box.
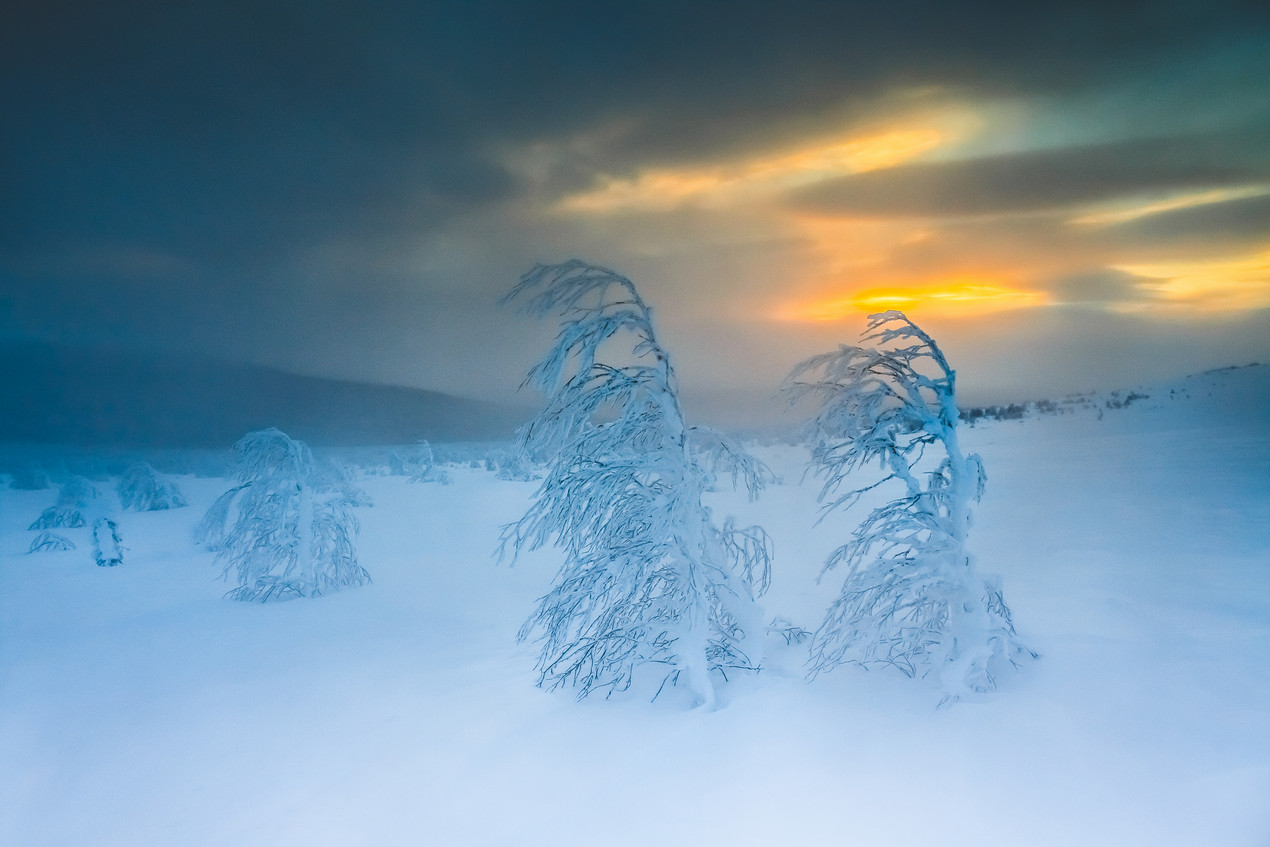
[1116,250,1270,314]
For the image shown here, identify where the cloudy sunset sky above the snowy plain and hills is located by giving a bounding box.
[0,0,1270,423]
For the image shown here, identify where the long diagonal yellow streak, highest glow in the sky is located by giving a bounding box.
[560,112,973,213]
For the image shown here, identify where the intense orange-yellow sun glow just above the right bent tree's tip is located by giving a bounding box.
[776,281,1049,323]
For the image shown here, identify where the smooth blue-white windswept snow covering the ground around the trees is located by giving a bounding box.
[0,367,1270,847]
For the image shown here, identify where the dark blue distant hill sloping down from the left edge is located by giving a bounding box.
[0,343,526,447]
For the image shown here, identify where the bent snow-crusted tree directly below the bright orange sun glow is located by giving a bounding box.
[785,311,1035,700]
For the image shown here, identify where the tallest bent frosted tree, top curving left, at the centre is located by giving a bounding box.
[502,260,771,707]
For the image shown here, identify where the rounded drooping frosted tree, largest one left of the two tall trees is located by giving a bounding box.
[196,428,371,603]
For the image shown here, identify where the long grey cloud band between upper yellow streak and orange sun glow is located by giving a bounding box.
[792,133,1270,217]
